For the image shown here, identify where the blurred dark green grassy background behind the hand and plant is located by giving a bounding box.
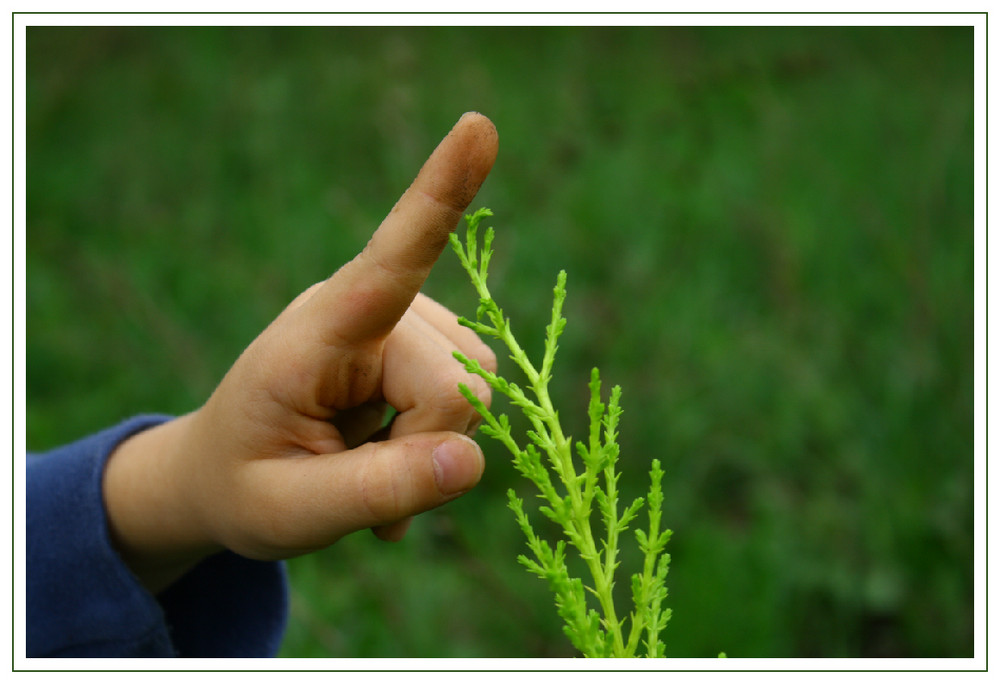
[26,27,974,657]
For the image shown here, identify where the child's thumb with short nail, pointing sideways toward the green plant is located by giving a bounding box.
[250,432,485,557]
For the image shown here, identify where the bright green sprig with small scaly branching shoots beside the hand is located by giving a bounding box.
[451,208,671,657]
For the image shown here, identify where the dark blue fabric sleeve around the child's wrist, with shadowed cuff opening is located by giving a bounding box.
[26,416,288,658]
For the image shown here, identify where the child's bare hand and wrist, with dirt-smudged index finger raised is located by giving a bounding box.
[104,113,497,593]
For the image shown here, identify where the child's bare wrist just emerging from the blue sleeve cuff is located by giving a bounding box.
[104,414,221,593]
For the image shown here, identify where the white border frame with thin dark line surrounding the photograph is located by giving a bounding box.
[5,9,997,678]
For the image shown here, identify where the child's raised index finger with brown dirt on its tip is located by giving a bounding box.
[309,112,497,343]
